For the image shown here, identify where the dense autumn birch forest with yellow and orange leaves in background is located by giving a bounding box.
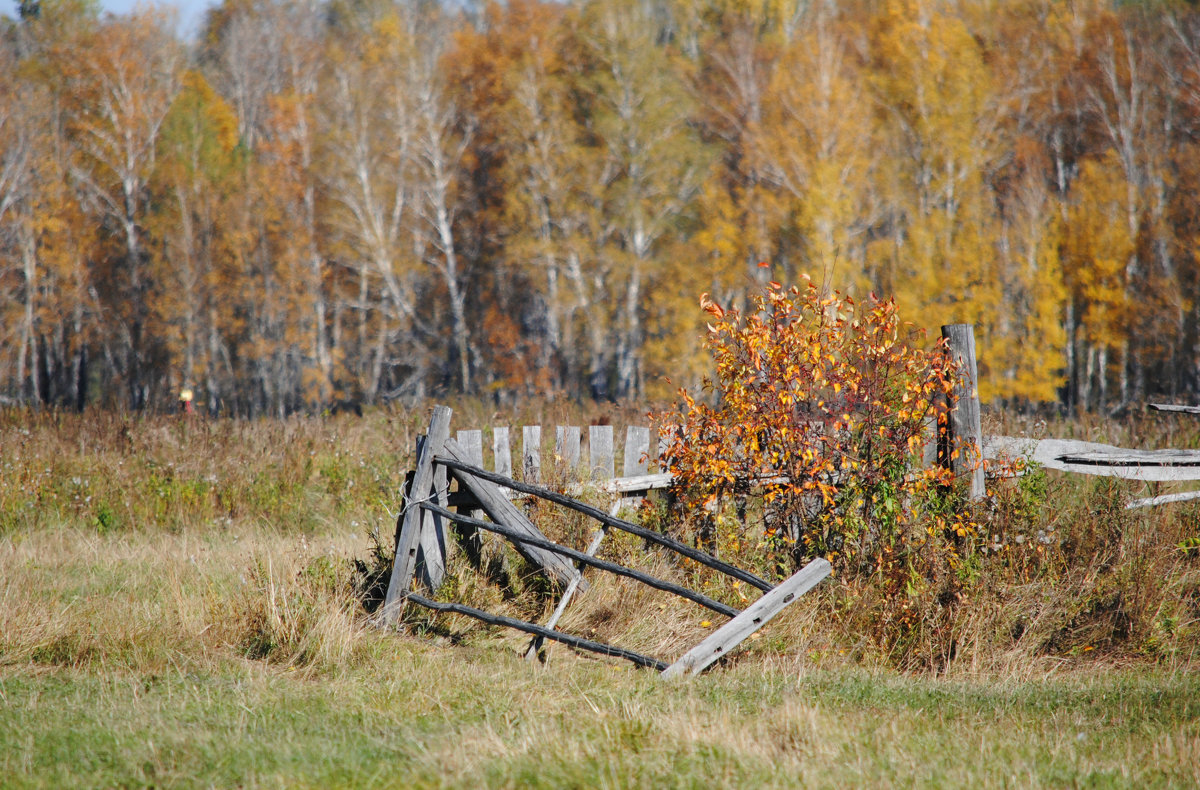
[0,0,1200,415]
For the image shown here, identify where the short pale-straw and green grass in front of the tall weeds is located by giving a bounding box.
[0,516,1200,788]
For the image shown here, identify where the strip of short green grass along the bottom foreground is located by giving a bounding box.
[0,653,1200,788]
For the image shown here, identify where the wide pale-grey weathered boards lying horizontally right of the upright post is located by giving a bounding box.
[984,436,1200,483]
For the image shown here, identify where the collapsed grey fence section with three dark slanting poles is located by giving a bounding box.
[379,406,830,677]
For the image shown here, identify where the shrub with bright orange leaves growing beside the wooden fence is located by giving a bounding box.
[660,281,970,581]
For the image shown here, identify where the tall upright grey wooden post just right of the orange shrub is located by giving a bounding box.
[938,324,985,499]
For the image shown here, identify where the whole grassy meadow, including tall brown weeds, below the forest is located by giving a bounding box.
[0,403,1200,788]
